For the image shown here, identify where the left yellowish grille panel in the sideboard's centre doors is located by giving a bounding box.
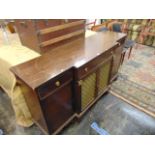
[81,73,96,110]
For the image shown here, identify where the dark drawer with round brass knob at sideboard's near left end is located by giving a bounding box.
[38,71,73,99]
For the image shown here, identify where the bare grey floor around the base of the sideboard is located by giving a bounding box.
[0,90,155,135]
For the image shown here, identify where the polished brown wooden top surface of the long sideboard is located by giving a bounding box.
[11,31,126,89]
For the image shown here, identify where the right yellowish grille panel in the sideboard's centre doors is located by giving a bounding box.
[98,62,110,95]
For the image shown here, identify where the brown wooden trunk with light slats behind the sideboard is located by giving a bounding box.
[15,19,85,54]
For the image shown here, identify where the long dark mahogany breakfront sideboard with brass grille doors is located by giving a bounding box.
[11,31,126,134]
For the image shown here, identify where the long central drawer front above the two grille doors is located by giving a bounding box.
[76,51,111,80]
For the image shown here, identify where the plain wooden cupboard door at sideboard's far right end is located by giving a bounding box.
[111,45,123,79]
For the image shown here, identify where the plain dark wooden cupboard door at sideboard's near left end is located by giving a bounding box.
[41,84,73,134]
